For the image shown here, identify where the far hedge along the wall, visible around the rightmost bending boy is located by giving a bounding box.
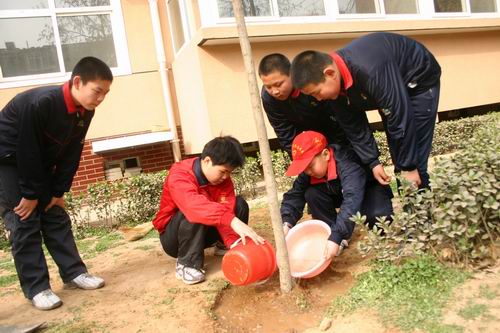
[373,114,492,165]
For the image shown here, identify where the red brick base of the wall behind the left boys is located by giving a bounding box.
[71,127,184,193]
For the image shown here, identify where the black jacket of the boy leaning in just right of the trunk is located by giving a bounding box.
[261,87,347,154]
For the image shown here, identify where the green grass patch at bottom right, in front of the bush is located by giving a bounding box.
[327,257,467,333]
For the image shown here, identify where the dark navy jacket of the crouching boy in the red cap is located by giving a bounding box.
[281,144,374,244]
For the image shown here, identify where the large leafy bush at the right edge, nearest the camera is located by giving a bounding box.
[353,116,500,266]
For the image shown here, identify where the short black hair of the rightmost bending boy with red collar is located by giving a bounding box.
[291,50,333,89]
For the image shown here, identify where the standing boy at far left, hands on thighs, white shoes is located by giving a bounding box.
[0,57,113,310]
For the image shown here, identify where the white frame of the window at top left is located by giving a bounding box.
[0,0,131,89]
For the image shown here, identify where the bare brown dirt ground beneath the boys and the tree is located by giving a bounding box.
[0,208,500,333]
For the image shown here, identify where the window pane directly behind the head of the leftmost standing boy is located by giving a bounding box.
[57,15,117,72]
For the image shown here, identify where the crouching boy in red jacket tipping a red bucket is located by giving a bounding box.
[153,136,264,284]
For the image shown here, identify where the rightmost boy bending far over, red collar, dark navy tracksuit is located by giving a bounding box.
[291,33,441,188]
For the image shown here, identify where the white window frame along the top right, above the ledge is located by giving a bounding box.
[198,0,500,27]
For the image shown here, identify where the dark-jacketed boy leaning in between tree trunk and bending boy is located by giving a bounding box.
[259,53,348,155]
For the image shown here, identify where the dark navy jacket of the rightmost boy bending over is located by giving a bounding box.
[332,33,441,170]
